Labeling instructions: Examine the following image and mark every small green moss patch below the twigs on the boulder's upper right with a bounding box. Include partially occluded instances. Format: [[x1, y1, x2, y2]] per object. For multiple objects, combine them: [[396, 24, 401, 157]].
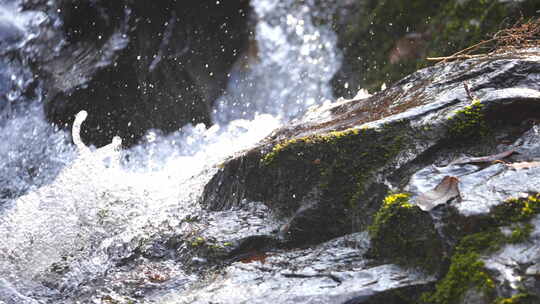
[[449, 100, 489, 139]]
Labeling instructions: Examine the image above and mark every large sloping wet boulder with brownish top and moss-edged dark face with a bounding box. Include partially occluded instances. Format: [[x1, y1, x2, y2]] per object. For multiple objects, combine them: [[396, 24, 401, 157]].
[[202, 48, 540, 243]]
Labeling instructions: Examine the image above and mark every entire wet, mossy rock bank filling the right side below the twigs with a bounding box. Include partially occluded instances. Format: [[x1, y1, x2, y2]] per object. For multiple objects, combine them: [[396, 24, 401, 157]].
[[195, 49, 540, 303]]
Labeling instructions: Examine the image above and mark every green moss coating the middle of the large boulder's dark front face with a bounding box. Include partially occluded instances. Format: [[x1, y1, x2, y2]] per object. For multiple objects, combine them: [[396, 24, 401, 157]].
[[261, 122, 411, 237]]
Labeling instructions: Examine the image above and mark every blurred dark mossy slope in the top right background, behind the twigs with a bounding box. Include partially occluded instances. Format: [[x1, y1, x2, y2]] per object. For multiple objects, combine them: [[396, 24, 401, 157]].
[[333, 0, 540, 98]]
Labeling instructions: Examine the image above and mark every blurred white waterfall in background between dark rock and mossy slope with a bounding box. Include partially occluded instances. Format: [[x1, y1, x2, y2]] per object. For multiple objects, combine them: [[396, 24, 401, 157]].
[[214, 0, 341, 124]]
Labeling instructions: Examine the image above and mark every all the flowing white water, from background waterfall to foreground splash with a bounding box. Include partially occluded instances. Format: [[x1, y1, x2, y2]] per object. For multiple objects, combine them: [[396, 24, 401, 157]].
[[0, 0, 340, 304]]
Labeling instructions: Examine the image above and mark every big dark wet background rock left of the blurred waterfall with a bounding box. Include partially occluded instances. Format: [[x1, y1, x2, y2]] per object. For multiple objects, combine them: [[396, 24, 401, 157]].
[[25, 0, 250, 146]]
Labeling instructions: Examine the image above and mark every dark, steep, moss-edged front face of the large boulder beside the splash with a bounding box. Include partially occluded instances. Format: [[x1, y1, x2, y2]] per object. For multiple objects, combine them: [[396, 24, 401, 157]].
[[202, 120, 418, 245]]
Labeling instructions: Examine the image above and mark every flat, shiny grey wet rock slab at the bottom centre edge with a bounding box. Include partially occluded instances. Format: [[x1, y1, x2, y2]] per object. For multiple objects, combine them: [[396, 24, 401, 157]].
[[177, 233, 434, 303]]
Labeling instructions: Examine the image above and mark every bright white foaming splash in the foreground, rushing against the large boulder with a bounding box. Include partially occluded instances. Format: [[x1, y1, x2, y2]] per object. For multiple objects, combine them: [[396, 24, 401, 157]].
[[0, 108, 278, 298]]
